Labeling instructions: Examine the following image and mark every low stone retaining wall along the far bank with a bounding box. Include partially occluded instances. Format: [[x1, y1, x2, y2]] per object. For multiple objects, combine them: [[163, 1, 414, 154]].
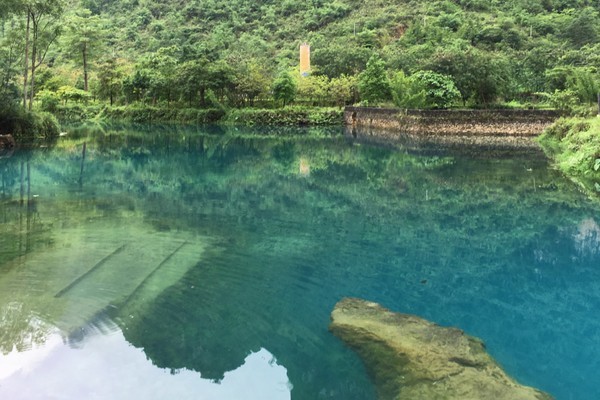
[[344, 107, 560, 142]]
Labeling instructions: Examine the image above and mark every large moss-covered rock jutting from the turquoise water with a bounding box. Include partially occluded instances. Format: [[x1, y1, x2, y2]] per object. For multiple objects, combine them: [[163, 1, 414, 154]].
[[329, 298, 552, 400]]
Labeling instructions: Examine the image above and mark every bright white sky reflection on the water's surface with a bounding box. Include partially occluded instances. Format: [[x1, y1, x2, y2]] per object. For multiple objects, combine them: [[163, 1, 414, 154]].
[[0, 331, 291, 400]]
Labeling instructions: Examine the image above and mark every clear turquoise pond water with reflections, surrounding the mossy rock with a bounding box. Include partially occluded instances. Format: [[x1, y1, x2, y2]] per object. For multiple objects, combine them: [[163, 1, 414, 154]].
[[0, 123, 600, 399]]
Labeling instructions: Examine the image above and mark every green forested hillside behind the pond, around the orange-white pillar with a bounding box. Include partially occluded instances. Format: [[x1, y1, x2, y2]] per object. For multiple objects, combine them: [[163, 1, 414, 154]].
[[0, 0, 600, 119]]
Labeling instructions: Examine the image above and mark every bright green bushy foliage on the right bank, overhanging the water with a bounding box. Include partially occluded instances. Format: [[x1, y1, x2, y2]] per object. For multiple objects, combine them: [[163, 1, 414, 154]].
[[540, 118, 600, 193]]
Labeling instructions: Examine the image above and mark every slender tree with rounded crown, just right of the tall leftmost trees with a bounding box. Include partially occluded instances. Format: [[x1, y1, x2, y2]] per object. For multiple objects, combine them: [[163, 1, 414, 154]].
[[65, 9, 106, 92]]
